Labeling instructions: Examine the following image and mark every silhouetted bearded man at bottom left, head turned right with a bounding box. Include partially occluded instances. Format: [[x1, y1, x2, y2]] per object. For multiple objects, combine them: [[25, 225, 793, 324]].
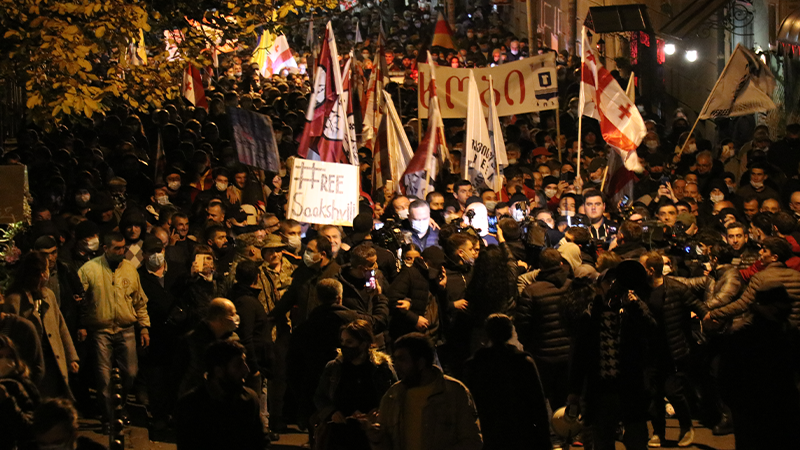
[[175, 341, 265, 450]]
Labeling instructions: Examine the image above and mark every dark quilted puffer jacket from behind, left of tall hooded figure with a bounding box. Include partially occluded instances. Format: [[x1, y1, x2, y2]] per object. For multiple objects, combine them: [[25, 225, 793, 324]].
[[514, 266, 572, 363]]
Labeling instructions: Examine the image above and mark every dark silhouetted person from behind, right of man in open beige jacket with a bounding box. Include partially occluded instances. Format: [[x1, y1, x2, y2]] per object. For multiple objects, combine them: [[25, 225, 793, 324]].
[[464, 314, 551, 450]]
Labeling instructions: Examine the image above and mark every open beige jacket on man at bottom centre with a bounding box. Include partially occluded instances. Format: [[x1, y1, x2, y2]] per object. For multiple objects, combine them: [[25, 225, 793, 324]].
[[372, 369, 483, 450]]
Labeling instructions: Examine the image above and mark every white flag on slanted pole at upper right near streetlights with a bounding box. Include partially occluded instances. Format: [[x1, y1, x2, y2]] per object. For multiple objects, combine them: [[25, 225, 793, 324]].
[[700, 44, 775, 120]]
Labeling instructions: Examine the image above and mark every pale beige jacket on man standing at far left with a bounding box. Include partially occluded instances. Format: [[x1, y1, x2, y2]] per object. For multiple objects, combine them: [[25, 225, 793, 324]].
[[78, 255, 150, 333]]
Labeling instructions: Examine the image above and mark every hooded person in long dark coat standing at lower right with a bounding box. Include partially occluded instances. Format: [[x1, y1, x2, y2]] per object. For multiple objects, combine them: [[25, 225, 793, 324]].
[[567, 261, 656, 450]]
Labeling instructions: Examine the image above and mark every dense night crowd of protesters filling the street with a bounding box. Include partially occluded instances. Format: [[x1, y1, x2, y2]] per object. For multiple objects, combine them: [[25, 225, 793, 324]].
[[0, 2, 800, 450]]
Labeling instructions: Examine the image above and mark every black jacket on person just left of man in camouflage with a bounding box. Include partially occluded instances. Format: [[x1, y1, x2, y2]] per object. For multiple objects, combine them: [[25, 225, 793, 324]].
[[228, 283, 273, 378]]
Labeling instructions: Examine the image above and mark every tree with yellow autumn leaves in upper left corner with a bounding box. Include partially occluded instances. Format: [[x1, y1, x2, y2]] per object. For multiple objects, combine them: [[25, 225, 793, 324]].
[[0, 0, 338, 128]]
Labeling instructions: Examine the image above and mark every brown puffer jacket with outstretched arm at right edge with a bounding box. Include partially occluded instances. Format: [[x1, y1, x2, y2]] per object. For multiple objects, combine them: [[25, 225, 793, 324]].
[[711, 262, 800, 331]]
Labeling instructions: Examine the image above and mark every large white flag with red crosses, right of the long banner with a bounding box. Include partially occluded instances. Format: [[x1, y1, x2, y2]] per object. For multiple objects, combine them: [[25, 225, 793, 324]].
[[579, 28, 647, 172]]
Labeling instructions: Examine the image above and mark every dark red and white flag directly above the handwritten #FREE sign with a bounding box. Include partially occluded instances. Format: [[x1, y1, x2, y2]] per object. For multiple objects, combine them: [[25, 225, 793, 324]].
[[297, 22, 358, 165]]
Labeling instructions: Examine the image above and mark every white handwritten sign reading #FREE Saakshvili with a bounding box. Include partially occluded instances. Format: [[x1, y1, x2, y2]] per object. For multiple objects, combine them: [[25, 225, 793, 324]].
[[288, 158, 359, 226]]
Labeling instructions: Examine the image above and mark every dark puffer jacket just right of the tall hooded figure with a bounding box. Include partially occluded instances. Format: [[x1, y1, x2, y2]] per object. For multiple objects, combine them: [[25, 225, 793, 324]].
[[651, 277, 708, 361]]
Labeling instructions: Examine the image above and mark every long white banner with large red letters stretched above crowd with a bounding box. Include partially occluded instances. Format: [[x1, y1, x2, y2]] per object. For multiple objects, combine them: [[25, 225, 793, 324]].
[[418, 53, 558, 119]]
